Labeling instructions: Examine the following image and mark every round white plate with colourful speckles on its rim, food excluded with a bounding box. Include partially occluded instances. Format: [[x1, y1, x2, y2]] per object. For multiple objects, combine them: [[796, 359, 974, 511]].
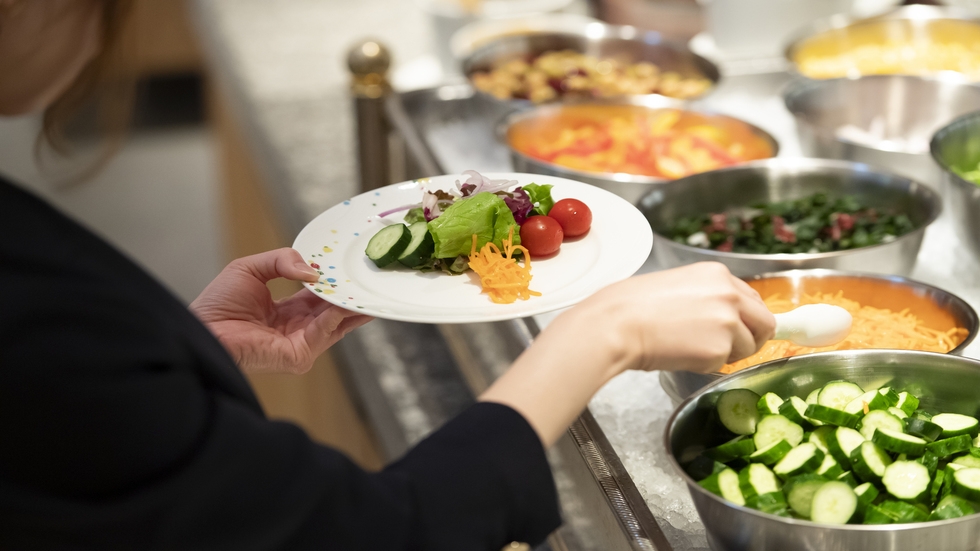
[[293, 173, 653, 323]]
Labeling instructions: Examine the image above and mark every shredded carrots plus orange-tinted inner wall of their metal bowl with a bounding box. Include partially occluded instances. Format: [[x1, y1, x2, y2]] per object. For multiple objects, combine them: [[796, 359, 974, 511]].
[[721, 276, 969, 373]]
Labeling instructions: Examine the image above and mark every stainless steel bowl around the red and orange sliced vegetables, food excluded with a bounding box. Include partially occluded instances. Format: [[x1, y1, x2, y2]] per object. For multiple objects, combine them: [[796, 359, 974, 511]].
[[497, 96, 779, 203]]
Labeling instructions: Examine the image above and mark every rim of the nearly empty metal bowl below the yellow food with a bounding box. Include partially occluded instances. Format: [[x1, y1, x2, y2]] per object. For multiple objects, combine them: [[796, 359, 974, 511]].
[[782, 73, 980, 156]]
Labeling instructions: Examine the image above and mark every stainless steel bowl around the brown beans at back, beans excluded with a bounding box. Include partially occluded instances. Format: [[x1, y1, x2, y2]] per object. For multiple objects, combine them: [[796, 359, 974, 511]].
[[462, 22, 721, 108]]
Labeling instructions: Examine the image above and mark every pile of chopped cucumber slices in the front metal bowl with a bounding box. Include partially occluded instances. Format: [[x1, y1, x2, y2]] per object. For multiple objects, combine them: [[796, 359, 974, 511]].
[[687, 381, 980, 524]]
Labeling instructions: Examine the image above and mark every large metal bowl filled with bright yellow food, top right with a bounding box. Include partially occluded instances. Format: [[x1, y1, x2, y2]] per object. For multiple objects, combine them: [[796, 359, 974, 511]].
[[786, 5, 980, 80]]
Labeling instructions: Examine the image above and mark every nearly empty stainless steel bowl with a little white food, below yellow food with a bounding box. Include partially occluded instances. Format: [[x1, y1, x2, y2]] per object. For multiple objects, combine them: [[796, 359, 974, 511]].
[[783, 75, 980, 190]]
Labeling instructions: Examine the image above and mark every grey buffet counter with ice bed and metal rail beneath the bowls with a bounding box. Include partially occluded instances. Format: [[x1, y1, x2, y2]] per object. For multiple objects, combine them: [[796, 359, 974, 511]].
[[194, 0, 980, 551]]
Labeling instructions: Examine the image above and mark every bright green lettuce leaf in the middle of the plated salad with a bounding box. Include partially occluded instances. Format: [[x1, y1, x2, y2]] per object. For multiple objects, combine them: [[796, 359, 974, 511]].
[[429, 192, 521, 258]]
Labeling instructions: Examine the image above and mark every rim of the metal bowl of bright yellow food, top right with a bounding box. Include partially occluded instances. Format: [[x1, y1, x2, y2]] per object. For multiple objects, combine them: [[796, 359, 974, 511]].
[[783, 4, 980, 80]]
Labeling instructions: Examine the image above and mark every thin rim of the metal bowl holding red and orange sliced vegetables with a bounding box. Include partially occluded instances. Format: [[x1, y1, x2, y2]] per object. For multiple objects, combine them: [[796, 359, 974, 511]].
[[496, 102, 779, 189]]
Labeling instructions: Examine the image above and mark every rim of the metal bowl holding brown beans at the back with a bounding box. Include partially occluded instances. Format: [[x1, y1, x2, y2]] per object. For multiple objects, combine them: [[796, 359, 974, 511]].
[[460, 21, 723, 108]]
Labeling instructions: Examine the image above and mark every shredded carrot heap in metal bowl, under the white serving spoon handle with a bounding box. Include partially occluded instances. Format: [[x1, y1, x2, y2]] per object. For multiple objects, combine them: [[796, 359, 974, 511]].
[[721, 292, 969, 373]]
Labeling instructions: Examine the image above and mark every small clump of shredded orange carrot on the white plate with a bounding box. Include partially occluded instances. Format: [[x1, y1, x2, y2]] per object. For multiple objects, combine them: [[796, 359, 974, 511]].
[[470, 226, 541, 304]]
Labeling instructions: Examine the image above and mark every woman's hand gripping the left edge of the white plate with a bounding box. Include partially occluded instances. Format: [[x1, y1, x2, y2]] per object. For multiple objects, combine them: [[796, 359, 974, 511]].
[[190, 248, 372, 373]]
